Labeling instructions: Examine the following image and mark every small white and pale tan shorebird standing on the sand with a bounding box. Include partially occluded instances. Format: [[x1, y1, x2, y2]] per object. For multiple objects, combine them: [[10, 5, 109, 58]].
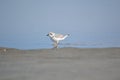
[[47, 32, 69, 48]]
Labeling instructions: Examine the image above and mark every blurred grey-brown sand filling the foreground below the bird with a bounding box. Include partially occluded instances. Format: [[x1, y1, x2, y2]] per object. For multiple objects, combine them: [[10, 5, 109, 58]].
[[0, 48, 120, 80]]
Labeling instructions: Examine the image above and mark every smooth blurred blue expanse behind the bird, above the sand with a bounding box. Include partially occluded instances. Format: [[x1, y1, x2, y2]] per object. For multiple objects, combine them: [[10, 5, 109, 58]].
[[0, 0, 120, 49]]
